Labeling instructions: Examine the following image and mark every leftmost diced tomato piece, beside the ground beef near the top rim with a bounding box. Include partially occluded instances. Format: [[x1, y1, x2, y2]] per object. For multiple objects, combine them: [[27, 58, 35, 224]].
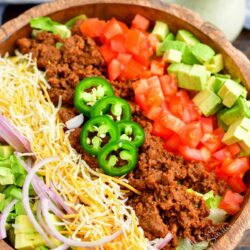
[[80, 18, 106, 38]]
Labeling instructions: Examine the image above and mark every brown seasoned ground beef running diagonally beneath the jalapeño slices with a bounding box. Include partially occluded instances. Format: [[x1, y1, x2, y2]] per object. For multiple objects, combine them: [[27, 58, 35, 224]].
[[17, 23, 227, 249]]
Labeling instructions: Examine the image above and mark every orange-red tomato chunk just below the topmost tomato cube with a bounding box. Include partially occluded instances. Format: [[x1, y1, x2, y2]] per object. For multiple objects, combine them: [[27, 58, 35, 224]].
[[125, 29, 146, 55]]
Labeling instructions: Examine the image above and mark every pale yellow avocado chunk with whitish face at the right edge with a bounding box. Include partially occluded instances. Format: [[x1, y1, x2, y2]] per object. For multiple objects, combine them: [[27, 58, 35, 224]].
[[222, 117, 250, 145]]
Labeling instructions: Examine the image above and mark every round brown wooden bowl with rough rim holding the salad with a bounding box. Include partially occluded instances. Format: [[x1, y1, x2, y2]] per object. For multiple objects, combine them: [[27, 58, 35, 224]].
[[0, 0, 250, 250]]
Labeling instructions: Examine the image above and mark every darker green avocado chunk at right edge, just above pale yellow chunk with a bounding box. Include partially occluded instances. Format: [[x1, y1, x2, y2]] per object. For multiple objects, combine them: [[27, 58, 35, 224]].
[[220, 97, 250, 125]]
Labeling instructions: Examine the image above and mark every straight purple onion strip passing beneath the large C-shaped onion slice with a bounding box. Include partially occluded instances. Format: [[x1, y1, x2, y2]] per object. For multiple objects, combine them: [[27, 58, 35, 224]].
[[15, 153, 75, 217]]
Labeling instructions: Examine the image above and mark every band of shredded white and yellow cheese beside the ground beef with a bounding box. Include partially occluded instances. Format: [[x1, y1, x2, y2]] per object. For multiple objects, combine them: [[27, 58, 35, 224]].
[[0, 54, 152, 250]]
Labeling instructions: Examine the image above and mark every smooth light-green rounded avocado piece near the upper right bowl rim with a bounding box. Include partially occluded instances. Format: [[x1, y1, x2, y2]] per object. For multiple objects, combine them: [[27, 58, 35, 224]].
[[191, 43, 215, 63]]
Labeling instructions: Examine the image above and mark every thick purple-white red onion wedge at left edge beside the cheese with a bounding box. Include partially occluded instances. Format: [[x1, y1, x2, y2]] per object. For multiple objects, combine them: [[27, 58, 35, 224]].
[[0, 114, 31, 153]]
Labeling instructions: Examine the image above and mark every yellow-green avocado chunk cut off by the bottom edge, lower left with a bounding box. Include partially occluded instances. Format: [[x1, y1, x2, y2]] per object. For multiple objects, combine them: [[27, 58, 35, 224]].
[[15, 233, 46, 250]]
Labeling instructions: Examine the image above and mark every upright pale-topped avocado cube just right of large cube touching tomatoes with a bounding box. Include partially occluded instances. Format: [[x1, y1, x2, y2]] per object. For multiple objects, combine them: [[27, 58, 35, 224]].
[[187, 64, 208, 90]]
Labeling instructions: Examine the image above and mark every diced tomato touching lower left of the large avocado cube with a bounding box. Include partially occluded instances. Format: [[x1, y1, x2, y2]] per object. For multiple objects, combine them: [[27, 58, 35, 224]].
[[159, 75, 178, 97]]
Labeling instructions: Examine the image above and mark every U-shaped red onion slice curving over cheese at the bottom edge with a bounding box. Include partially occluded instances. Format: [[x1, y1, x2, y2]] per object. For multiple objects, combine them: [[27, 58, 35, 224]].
[[41, 198, 122, 248]]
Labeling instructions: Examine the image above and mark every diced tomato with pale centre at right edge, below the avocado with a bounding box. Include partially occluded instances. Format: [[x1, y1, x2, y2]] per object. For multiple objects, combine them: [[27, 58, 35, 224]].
[[222, 157, 250, 177]]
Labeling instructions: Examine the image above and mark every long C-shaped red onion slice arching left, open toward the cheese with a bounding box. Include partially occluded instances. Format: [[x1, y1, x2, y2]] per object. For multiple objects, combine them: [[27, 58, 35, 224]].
[[22, 157, 59, 248]]
